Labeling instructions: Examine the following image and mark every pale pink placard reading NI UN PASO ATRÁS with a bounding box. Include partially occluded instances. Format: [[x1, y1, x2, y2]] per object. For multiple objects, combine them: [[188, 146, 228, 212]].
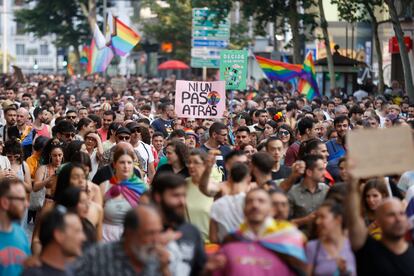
[[175, 80, 226, 118]]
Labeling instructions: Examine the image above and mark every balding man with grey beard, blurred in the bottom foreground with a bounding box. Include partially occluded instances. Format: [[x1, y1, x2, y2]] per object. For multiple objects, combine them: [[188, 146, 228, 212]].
[[71, 204, 171, 276]]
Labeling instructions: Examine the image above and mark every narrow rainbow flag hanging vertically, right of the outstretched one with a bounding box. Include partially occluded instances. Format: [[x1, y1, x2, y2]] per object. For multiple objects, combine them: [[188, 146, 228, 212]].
[[298, 52, 320, 101]]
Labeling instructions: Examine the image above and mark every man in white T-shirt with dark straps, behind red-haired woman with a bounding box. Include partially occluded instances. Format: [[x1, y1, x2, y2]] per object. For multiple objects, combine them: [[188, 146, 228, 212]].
[[126, 121, 155, 180]]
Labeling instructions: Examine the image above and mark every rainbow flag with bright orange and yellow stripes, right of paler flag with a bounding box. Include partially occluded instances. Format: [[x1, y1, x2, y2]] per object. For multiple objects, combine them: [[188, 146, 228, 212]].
[[110, 17, 141, 56]]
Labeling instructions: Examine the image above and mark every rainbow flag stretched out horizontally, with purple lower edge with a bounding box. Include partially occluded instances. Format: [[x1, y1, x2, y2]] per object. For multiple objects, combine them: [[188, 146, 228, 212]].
[[256, 56, 303, 82]]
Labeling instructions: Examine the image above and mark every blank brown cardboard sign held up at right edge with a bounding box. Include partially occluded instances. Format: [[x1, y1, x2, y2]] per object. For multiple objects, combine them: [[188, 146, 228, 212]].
[[347, 127, 414, 178]]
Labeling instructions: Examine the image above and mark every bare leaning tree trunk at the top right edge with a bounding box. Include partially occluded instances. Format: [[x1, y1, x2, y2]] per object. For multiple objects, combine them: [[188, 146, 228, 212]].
[[385, 0, 414, 102]]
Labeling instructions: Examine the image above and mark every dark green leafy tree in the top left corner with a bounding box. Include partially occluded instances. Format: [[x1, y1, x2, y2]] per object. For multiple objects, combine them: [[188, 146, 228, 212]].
[[15, 0, 101, 71]]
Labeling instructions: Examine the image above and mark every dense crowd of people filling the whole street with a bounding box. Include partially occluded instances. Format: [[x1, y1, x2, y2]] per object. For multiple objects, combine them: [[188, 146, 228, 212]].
[[0, 75, 414, 276]]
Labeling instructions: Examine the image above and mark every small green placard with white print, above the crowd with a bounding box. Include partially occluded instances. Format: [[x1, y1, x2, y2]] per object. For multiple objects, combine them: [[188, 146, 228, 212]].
[[220, 50, 248, 90]]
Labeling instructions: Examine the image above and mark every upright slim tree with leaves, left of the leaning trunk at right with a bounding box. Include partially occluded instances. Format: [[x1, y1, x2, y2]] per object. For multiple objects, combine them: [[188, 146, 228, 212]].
[[331, 0, 386, 93]]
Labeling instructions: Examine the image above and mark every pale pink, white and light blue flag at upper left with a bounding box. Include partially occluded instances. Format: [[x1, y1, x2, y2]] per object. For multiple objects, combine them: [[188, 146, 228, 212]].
[[86, 24, 114, 74]]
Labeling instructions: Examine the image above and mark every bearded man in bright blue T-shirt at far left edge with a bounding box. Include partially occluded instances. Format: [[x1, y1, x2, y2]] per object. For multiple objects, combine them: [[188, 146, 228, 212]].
[[0, 177, 30, 275]]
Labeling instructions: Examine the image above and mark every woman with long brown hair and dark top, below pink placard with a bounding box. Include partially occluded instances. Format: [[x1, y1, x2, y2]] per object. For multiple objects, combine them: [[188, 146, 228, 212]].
[[154, 140, 190, 178]]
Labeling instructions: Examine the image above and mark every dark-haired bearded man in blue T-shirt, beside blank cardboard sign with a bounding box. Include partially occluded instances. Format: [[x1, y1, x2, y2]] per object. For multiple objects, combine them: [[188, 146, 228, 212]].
[[326, 115, 350, 181]]
